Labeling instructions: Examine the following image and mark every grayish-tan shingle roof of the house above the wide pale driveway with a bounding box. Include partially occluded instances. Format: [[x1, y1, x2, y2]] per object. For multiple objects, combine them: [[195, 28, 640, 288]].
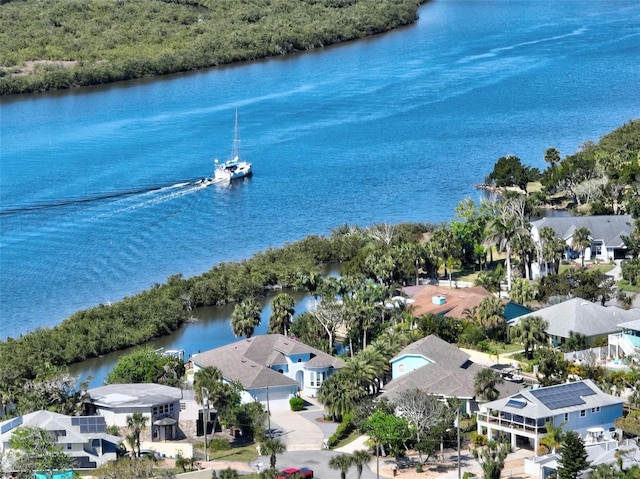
[[192, 334, 344, 389]]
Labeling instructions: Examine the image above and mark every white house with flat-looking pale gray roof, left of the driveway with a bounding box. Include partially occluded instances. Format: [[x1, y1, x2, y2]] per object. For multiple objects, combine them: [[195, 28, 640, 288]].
[[85, 383, 184, 441]]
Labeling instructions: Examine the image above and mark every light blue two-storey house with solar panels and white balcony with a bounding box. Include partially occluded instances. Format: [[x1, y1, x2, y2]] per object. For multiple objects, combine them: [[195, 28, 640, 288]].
[[477, 379, 624, 454]]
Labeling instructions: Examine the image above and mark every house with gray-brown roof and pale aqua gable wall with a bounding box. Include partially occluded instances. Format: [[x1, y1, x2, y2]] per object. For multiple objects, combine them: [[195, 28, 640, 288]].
[[382, 334, 521, 413]]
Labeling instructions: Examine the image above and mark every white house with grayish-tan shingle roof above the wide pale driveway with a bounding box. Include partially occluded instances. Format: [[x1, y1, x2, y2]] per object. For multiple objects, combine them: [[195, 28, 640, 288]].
[[191, 334, 344, 408]]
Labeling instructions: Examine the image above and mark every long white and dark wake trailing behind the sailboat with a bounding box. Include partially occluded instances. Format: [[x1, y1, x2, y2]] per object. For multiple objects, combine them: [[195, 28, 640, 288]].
[[0, 178, 208, 216]]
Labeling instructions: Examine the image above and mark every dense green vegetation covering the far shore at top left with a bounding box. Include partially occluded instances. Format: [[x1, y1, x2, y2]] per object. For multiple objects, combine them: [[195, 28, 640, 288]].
[[0, 0, 418, 95]]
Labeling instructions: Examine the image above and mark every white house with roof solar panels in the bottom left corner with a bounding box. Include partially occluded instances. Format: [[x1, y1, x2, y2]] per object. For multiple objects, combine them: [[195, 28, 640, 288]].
[[0, 411, 122, 472]]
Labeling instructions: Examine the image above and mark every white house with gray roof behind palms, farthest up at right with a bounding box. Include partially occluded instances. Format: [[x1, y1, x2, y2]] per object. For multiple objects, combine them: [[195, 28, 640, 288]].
[[531, 215, 633, 278]]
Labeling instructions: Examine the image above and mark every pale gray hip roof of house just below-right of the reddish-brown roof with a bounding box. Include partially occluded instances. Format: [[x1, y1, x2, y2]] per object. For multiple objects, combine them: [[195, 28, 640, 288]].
[[508, 298, 640, 346]]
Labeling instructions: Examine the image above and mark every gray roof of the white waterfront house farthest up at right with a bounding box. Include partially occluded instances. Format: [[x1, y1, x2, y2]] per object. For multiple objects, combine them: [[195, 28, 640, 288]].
[[531, 215, 633, 247]]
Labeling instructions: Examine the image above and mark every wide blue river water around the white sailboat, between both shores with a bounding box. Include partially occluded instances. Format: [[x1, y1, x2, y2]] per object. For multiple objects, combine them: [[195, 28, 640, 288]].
[[0, 0, 640, 338]]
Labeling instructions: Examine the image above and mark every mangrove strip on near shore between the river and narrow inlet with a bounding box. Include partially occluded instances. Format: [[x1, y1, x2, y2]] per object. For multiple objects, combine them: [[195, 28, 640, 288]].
[[0, 225, 426, 389]]
